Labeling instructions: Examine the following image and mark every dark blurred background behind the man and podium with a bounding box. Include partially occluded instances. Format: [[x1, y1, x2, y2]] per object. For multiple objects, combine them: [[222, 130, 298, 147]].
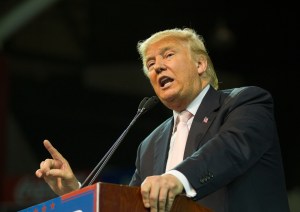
[[0, 0, 300, 212]]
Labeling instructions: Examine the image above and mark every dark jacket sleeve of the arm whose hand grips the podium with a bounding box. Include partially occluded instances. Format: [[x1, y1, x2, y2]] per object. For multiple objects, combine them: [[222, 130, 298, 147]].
[[176, 87, 278, 198]]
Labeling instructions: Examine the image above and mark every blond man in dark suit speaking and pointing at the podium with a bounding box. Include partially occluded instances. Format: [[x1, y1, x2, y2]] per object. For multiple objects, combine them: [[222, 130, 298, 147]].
[[36, 28, 289, 212]]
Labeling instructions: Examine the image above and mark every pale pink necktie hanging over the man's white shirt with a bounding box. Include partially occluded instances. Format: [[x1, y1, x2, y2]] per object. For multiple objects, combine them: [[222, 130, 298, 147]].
[[166, 110, 192, 171]]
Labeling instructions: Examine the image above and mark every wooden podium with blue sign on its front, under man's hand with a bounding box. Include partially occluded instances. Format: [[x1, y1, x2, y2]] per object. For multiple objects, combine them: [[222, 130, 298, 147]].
[[19, 182, 212, 212]]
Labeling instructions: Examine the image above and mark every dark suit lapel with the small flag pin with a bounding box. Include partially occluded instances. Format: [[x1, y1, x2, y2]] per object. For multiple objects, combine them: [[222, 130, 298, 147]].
[[184, 88, 220, 158]]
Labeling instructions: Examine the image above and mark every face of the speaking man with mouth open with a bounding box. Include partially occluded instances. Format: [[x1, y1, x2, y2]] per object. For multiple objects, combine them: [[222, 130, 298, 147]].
[[145, 37, 204, 111]]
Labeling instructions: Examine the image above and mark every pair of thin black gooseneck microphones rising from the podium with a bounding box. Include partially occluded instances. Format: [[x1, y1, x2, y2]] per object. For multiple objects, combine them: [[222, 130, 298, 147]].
[[80, 96, 158, 188]]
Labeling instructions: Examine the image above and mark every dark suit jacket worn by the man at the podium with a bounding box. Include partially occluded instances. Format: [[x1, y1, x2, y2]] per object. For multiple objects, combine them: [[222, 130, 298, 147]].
[[130, 86, 289, 212]]
